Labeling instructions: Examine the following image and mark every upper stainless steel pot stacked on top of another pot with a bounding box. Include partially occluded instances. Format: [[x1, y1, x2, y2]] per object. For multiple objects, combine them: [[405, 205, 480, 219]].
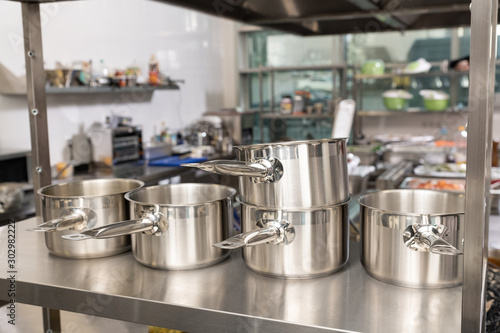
[[183, 138, 349, 208]]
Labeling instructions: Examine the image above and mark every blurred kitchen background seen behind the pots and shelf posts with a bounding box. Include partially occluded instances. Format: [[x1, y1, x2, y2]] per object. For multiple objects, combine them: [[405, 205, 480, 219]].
[[0, 0, 500, 222]]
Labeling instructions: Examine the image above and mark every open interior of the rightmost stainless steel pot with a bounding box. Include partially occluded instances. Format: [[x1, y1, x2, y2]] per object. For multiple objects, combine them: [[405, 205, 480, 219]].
[[358, 189, 465, 215]]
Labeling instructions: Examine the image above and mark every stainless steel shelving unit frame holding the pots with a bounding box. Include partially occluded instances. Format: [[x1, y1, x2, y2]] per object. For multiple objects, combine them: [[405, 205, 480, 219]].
[[0, 0, 498, 332]]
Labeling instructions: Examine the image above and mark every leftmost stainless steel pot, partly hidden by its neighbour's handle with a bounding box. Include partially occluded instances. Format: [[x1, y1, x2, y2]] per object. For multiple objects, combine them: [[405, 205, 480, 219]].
[[30, 179, 144, 259]]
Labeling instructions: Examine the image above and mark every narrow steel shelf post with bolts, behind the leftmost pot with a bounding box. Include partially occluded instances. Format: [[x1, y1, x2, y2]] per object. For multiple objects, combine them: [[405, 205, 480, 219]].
[[22, 2, 52, 215]]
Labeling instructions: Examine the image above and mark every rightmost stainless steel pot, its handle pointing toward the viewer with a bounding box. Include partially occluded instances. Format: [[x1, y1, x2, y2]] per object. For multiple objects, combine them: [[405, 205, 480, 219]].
[[358, 189, 465, 288]]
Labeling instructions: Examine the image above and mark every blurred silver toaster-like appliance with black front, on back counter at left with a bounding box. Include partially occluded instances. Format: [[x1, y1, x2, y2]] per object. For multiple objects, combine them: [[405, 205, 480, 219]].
[[88, 118, 143, 167]]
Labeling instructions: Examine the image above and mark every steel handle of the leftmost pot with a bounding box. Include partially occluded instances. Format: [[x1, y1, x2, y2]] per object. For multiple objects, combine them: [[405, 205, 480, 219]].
[[26, 208, 97, 232]]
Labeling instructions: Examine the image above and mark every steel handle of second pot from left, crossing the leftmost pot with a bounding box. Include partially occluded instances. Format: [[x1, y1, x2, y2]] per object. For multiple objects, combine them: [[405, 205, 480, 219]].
[[61, 213, 168, 241]]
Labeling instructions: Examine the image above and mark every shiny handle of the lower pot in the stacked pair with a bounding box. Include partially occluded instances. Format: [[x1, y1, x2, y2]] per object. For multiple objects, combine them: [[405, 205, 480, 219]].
[[212, 219, 295, 250]]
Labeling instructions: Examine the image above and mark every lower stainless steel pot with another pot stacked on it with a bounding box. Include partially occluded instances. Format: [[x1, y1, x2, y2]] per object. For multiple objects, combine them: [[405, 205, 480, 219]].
[[214, 202, 349, 279]]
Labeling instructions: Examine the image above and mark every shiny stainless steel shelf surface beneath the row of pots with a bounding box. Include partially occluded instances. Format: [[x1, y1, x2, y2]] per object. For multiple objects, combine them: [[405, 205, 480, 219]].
[[0, 217, 462, 333]]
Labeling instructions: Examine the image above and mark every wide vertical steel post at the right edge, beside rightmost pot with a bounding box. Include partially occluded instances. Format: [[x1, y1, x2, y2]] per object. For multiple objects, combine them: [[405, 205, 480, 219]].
[[462, 0, 498, 333]]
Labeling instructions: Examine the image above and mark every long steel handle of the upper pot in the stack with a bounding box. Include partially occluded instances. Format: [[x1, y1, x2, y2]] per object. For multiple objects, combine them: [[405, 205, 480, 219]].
[[181, 157, 283, 183]]
